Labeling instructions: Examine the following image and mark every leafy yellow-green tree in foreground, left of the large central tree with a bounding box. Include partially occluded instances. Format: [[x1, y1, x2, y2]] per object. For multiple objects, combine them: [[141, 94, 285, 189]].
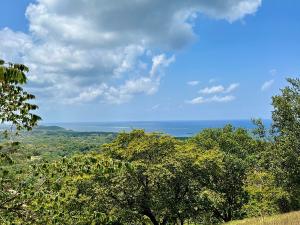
[[27, 153, 119, 225]]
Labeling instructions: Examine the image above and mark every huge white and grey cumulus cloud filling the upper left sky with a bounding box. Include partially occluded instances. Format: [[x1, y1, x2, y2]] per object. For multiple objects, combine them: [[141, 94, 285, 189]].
[[0, 0, 261, 103]]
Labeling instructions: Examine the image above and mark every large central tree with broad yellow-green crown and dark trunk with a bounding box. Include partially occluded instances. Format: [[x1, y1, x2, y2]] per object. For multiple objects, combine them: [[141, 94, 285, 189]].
[[100, 130, 199, 225]]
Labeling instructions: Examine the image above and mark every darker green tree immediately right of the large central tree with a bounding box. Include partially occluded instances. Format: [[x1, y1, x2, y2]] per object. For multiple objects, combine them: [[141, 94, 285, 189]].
[[190, 125, 258, 222]]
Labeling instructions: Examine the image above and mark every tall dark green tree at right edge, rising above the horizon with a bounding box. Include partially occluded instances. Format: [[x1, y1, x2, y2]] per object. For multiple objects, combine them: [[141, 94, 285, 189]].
[[272, 78, 300, 211]]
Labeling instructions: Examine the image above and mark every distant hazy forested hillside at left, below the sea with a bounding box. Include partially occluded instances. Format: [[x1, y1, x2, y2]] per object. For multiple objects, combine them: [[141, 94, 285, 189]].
[[0, 126, 116, 163]]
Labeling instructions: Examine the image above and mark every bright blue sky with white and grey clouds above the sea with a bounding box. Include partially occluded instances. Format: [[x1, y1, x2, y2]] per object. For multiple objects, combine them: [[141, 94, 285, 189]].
[[0, 0, 300, 122]]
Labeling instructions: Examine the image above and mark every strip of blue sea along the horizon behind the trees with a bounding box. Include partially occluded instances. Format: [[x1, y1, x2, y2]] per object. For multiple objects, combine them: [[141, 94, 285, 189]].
[[43, 120, 271, 137]]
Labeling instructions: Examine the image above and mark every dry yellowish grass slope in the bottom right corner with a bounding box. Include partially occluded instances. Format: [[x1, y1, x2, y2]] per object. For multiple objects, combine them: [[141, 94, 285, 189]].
[[224, 211, 300, 225]]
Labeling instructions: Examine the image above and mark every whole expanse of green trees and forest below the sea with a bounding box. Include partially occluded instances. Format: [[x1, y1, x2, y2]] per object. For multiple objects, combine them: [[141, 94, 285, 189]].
[[0, 60, 300, 225]]
